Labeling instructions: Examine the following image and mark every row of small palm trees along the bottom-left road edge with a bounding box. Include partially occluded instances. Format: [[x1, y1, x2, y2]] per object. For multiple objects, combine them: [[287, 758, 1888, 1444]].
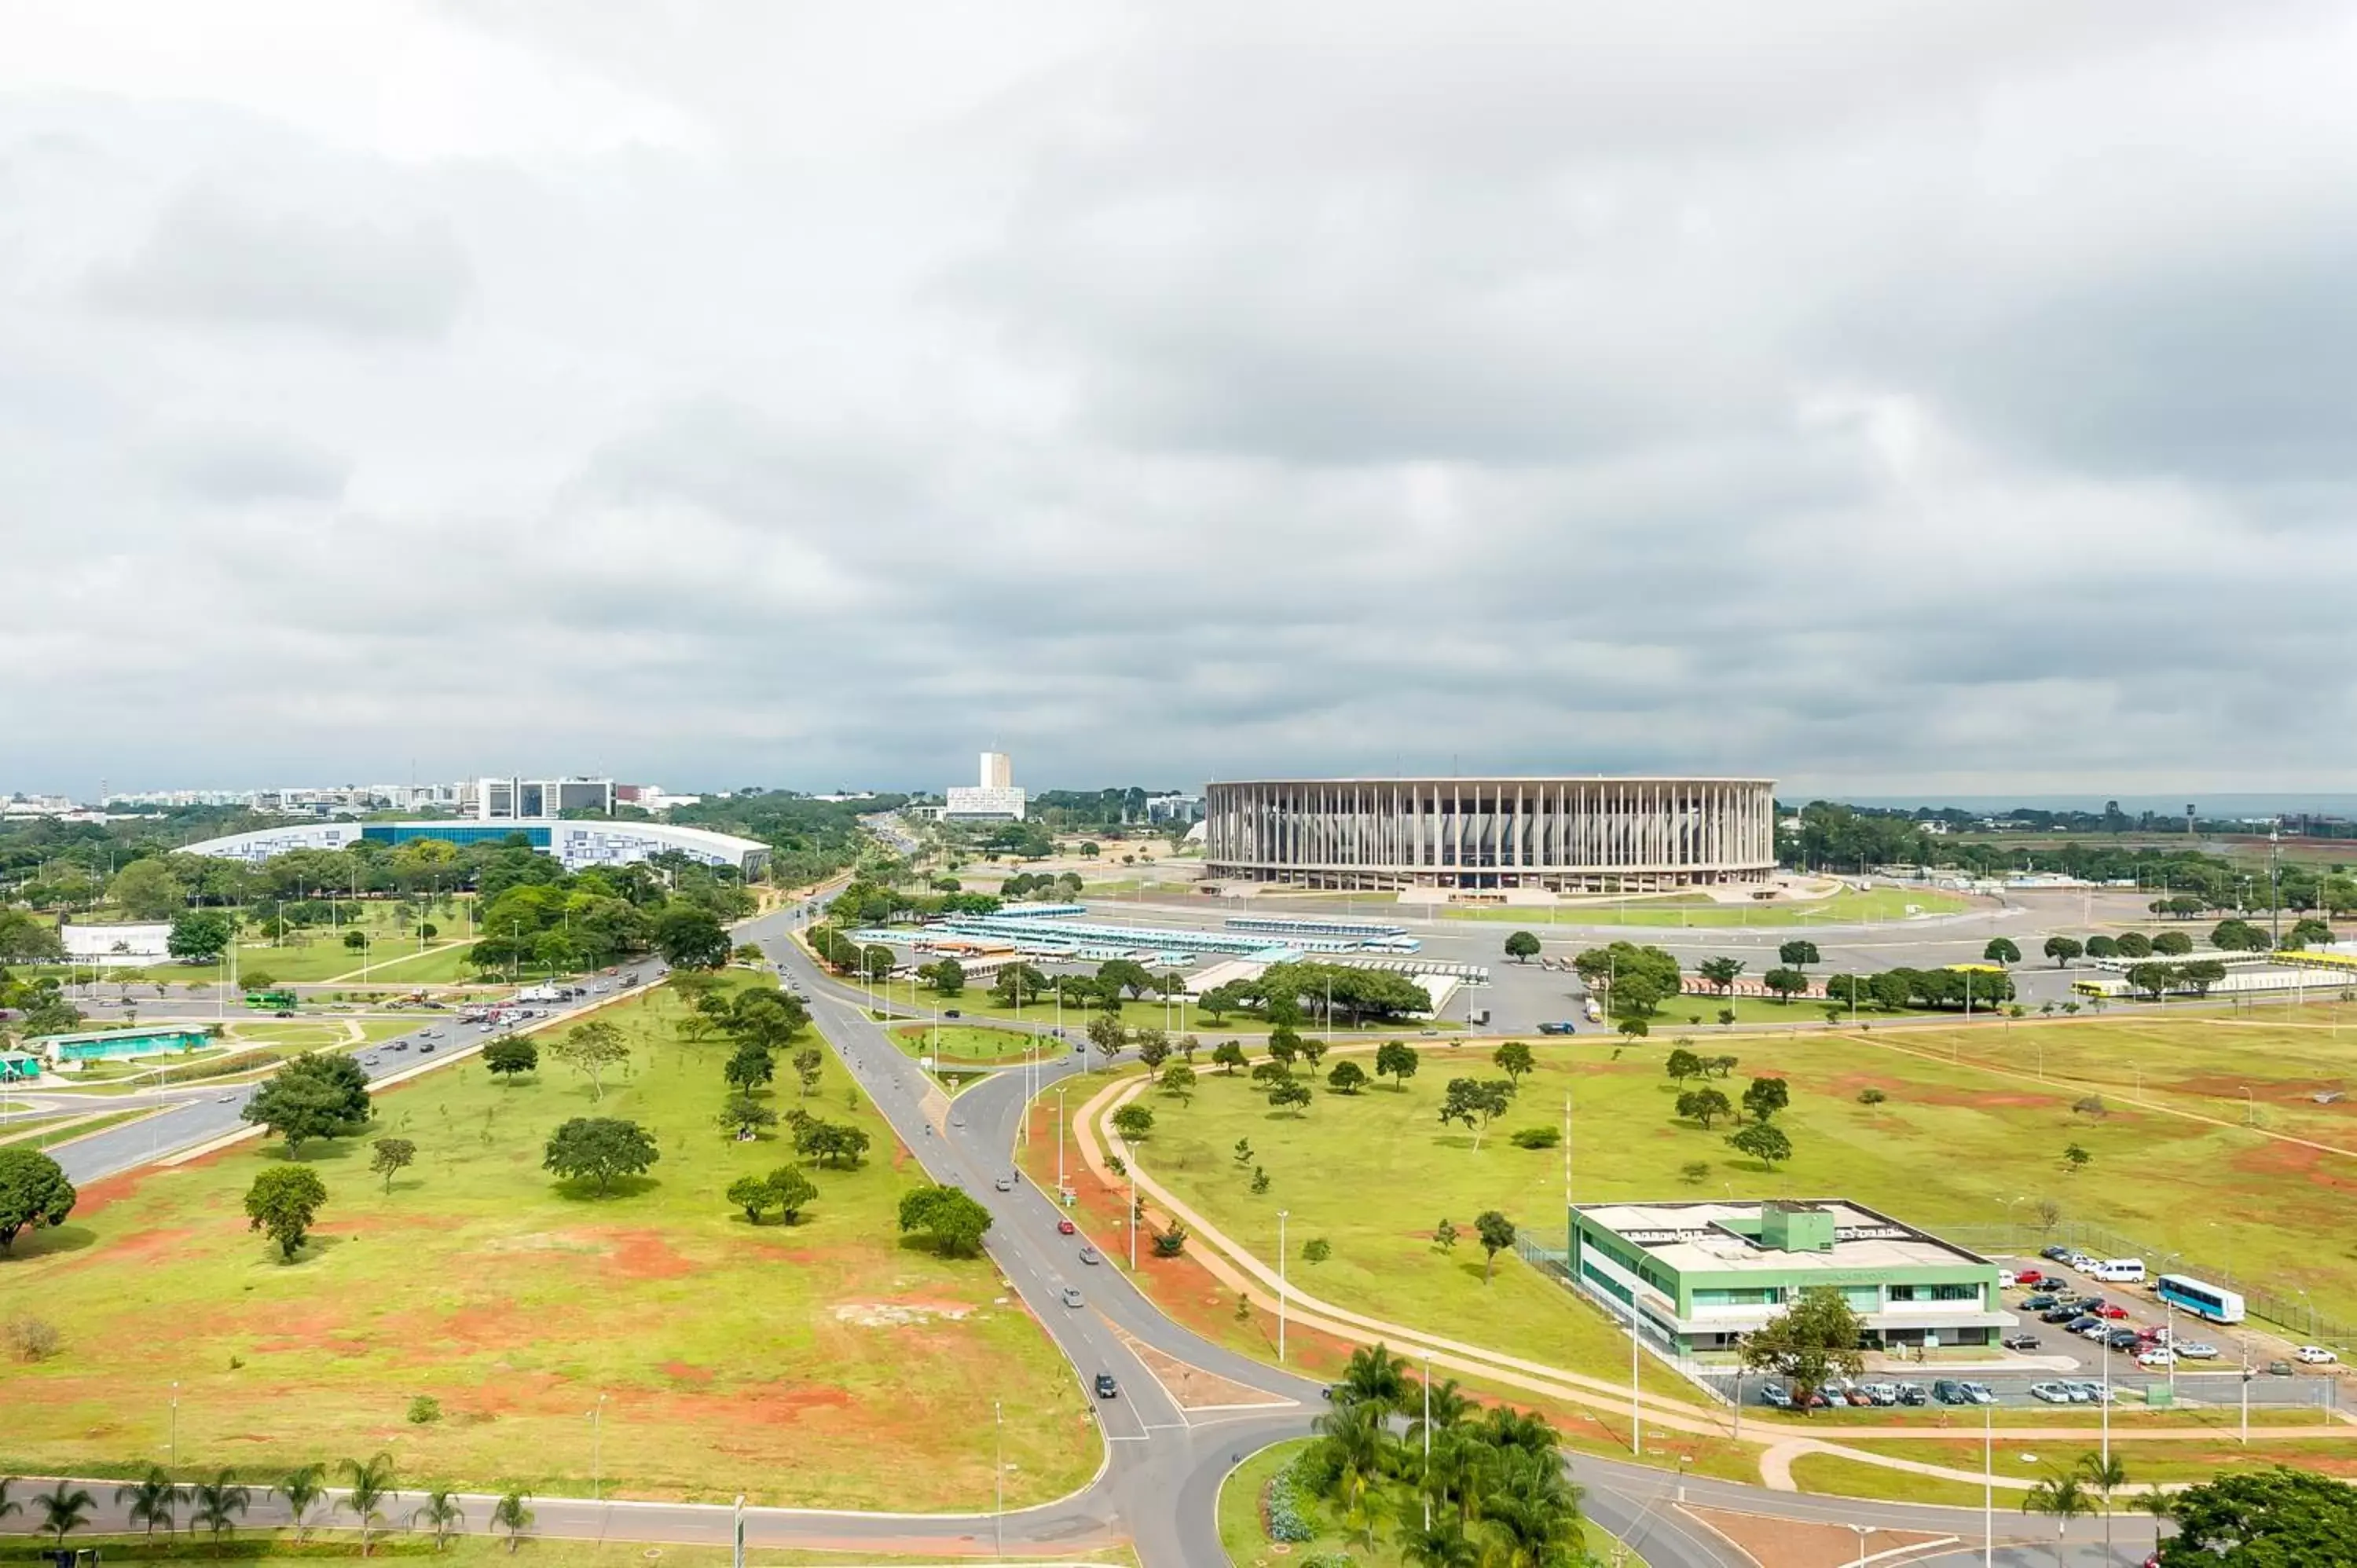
[[0, 1453, 533, 1556]]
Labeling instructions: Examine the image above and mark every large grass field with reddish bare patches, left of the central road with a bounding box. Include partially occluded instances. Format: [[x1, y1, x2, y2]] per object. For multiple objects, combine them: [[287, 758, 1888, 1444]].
[[0, 991, 1098, 1509]]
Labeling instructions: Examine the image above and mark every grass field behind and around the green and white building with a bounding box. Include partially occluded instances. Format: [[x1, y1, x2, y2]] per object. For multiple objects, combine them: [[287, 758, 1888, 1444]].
[[1141, 1019, 2357, 1370]]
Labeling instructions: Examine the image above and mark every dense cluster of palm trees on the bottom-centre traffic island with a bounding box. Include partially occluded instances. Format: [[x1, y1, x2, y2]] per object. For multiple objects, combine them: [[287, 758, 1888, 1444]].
[[1308, 1344, 1589, 1568]]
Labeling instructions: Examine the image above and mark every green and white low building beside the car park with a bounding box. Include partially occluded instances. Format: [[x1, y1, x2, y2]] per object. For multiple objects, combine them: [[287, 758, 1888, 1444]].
[[1570, 1198, 2018, 1361]]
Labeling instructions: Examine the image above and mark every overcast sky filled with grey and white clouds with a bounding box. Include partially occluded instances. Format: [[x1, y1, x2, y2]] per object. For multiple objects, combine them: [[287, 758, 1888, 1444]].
[[0, 0, 2357, 795]]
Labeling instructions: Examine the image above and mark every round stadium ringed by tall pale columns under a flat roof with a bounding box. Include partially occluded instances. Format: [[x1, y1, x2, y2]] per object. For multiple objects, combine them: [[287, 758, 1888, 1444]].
[[1204, 778, 1775, 894]]
